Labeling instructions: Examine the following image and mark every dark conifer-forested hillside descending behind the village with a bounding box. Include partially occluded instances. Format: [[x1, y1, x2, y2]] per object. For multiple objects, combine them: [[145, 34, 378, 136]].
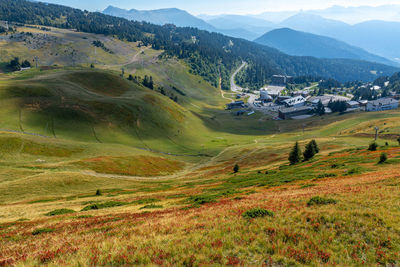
[[0, 0, 397, 89]]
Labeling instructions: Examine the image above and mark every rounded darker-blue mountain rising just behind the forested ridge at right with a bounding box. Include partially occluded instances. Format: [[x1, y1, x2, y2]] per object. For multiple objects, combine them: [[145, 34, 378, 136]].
[[255, 28, 398, 66]]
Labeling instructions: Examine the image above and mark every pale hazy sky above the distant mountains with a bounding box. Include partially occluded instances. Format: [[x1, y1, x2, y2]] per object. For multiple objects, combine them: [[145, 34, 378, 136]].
[[43, 0, 400, 15]]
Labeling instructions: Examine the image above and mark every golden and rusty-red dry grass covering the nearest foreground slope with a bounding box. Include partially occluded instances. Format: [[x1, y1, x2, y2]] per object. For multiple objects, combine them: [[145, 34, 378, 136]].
[[0, 144, 400, 266]]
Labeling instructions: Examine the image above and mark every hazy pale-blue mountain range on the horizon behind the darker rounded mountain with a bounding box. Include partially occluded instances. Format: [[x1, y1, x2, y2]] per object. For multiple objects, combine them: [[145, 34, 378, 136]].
[[103, 6, 400, 64]]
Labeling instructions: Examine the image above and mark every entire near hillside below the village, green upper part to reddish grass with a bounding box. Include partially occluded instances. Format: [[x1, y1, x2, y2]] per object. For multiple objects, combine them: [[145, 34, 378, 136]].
[[0, 107, 400, 266]]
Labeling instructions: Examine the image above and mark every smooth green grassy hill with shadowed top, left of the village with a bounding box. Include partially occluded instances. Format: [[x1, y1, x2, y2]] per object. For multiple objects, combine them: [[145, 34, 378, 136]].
[[0, 27, 288, 155]]
